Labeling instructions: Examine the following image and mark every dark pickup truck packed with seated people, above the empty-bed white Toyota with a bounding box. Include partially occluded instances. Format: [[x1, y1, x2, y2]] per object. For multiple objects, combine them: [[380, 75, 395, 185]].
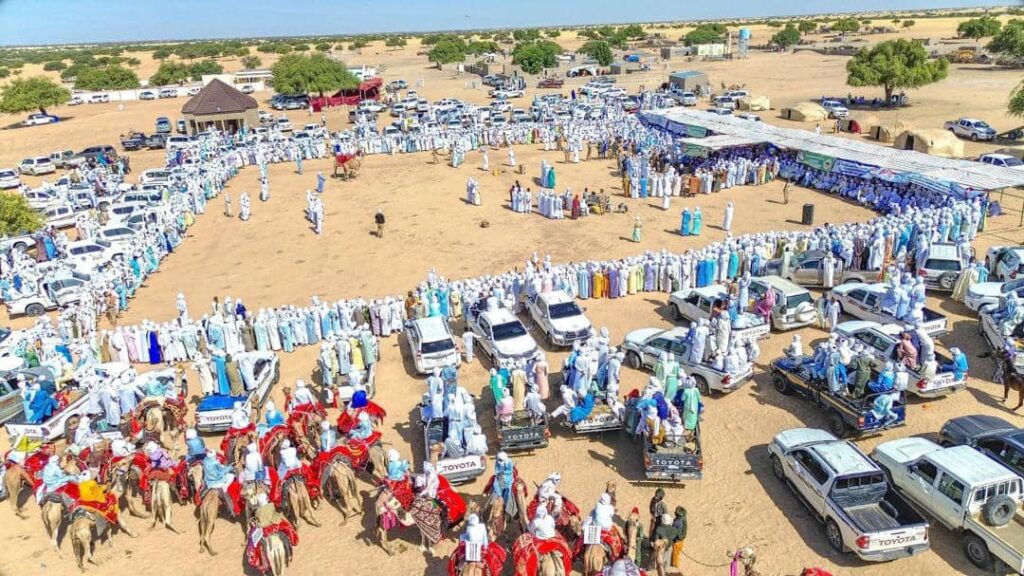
[[771, 357, 906, 438]]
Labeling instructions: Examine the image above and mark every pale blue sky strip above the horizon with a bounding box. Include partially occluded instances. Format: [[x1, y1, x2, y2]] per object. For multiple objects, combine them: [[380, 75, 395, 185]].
[[0, 0, 997, 45]]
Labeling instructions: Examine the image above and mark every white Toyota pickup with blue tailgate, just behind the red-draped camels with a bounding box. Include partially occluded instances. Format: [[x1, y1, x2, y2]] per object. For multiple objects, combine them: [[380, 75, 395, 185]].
[[196, 352, 281, 434]]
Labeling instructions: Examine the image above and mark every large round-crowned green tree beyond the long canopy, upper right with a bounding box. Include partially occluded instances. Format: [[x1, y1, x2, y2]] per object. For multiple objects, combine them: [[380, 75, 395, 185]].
[[846, 40, 949, 101]]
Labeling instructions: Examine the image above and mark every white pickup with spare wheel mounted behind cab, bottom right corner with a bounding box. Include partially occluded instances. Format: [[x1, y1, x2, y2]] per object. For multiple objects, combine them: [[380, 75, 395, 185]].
[[871, 438, 1024, 574]]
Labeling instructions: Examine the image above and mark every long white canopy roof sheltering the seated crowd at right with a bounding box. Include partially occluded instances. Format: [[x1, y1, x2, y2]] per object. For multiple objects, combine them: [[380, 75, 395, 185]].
[[640, 107, 1024, 191]]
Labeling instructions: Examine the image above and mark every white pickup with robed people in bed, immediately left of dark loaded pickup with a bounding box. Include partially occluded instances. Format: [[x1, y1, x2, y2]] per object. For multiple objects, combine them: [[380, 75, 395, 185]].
[[622, 328, 754, 396]]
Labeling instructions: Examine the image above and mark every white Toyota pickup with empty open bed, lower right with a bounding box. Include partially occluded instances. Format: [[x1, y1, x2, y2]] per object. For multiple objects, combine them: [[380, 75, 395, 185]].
[[768, 428, 930, 562]]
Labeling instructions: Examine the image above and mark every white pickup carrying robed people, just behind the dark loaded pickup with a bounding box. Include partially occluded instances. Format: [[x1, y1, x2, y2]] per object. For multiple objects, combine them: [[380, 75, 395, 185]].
[[836, 320, 967, 398]]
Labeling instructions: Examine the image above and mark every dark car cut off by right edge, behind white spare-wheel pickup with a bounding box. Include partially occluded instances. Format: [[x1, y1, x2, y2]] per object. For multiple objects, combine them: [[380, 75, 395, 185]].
[[939, 414, 1024, 478]]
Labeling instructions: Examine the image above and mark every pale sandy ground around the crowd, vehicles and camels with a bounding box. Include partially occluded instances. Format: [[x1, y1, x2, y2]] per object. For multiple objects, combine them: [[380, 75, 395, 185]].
[[0, 15, 1021, 576]]
